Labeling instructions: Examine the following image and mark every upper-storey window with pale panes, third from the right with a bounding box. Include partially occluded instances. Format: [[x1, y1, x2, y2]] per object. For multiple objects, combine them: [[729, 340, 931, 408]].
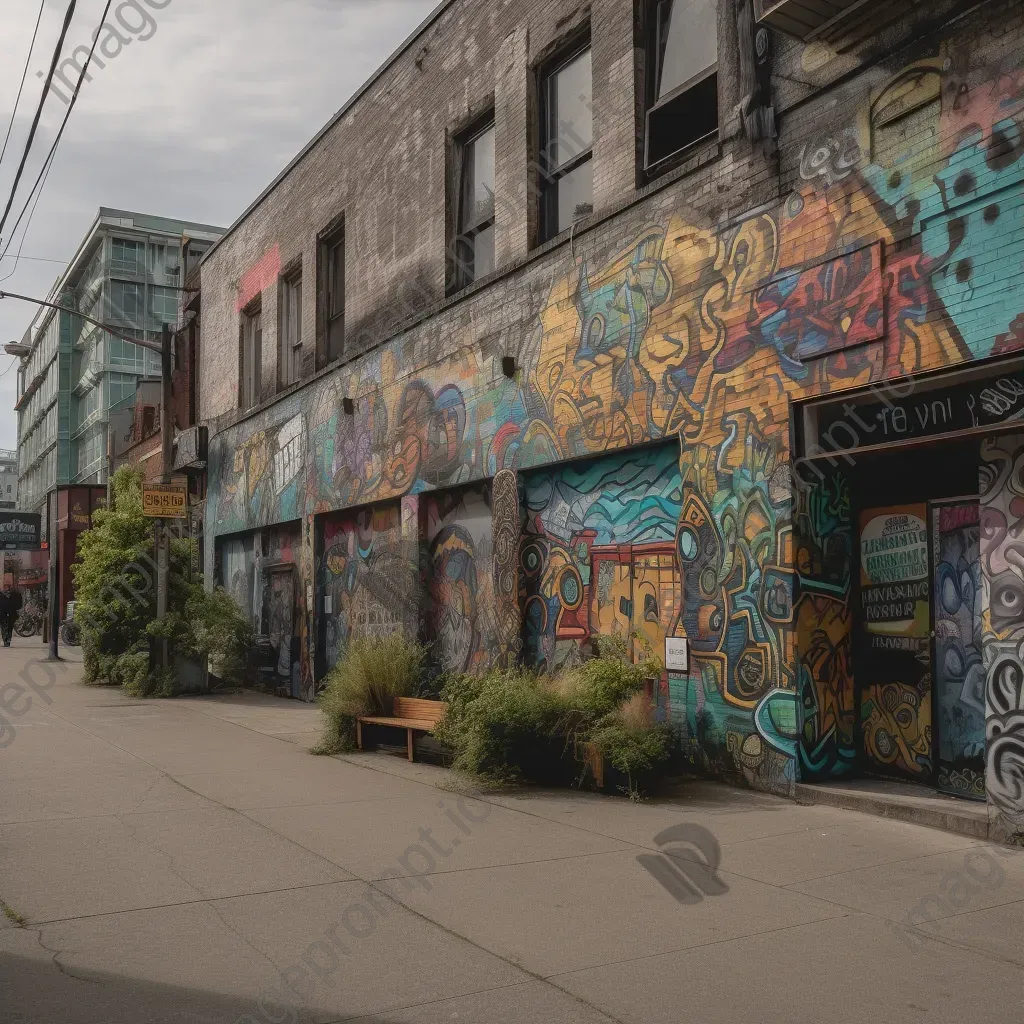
[[452, 115, 495, 289]]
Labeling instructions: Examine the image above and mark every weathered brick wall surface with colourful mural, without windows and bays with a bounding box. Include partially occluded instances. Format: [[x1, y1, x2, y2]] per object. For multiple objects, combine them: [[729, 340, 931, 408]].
[[197, 0, 1024, 791]]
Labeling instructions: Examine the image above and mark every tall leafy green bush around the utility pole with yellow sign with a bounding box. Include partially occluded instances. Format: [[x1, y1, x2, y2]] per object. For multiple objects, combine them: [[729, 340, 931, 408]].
[[72, 467, 252, 696]]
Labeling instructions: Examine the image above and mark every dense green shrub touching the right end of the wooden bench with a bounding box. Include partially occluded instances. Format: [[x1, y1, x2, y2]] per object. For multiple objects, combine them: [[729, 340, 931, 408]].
[[434, 669, 565, 782]]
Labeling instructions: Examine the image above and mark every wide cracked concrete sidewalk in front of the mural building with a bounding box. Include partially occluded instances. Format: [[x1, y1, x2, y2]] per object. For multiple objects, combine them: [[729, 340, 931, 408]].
[[0, 641, 1024, 1024]]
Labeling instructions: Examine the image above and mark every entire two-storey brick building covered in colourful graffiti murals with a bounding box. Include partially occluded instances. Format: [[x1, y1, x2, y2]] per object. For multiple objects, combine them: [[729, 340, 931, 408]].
[[199, 0, 1024, 836]]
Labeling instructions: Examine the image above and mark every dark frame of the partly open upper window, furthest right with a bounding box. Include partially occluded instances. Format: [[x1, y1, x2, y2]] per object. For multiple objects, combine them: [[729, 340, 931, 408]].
[[640, 0, 721, 180]]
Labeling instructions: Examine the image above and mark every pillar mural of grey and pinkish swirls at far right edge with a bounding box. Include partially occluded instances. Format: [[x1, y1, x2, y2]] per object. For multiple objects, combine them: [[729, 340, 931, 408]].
[[981, 434, 1024, 844]]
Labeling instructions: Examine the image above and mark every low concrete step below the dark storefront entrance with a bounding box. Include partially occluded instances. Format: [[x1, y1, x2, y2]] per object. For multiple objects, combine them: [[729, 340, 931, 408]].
[[796, 778, 988, 839]]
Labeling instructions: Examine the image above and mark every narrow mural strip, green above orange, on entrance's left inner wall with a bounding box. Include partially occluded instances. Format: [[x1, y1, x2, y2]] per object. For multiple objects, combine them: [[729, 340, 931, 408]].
[[794, 466, 857, 779]]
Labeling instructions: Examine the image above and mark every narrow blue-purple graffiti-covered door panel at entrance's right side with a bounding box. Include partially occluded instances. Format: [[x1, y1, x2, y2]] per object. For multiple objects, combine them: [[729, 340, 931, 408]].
[[932, 501, 985, 800]]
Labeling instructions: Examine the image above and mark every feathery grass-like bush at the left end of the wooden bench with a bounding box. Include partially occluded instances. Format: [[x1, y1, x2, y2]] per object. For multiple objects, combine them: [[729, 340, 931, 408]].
[[312, 633, 426, 754]]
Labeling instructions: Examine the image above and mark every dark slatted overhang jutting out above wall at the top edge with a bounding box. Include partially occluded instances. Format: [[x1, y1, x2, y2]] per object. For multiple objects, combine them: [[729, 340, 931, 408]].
[[754, 0, 922, 49]]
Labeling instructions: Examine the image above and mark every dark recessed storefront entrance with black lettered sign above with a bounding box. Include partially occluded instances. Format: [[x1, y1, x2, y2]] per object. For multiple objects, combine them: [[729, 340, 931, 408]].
[[795, 360, 1024, 800]]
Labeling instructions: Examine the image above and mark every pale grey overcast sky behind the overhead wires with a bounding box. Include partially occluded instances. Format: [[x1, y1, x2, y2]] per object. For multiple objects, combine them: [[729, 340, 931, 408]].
[[0, 0, 437, 449]]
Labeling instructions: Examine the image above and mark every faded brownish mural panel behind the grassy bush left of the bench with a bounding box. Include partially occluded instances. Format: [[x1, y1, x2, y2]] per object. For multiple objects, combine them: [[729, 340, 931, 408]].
[[316, 502, 419, 671]]
